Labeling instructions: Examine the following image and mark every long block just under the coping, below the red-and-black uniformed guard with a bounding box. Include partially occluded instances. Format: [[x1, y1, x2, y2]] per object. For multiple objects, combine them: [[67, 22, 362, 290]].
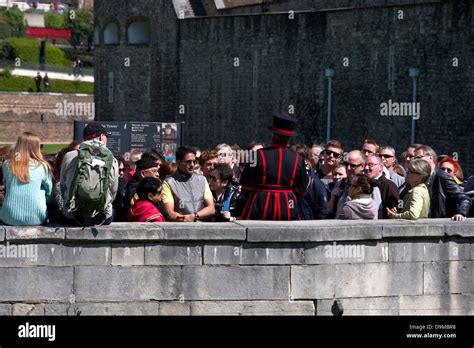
[[204, 243, 304, 265]]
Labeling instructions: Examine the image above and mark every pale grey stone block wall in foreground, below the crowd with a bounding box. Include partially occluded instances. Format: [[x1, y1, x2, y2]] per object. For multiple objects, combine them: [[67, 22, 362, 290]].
[[0, 219, 474, 315]]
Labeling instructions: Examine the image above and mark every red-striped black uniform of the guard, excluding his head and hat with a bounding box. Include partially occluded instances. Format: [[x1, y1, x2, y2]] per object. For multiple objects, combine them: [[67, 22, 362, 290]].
[[240, 146, 309, 221]]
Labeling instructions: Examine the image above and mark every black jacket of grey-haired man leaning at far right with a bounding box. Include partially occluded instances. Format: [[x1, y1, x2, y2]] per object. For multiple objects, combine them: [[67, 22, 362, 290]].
[[429, 168, 471, 218]]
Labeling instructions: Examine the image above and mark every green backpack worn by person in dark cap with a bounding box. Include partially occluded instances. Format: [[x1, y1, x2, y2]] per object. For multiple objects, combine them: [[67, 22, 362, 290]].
[[68, 144, 114, 226]]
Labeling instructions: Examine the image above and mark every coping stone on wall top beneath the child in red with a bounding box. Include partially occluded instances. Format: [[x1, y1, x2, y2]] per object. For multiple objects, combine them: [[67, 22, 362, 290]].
[[66, 222, 164, 241]]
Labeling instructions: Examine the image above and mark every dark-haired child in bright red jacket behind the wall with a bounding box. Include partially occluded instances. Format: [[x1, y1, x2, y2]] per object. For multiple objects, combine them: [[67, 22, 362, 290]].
[[127, 177, 165, 222]]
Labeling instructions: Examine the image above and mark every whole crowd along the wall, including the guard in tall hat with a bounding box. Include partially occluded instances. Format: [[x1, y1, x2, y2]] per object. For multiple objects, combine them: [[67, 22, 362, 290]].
[[0, 114, 474, 226]]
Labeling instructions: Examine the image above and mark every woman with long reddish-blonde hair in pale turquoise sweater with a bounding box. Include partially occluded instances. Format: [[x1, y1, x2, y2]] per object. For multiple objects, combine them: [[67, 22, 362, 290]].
[[0, 132, 53, 226]]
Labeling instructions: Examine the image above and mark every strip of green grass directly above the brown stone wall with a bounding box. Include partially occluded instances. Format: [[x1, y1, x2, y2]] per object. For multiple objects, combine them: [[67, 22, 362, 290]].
[[0, 74, 94, 94]]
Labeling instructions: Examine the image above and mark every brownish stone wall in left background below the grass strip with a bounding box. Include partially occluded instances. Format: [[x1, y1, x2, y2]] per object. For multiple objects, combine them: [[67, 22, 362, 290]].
[[0, 92, 94, 143]]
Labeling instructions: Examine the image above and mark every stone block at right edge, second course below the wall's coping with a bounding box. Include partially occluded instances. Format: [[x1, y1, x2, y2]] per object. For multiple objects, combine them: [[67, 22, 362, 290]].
[[424, 261, 474, 295]]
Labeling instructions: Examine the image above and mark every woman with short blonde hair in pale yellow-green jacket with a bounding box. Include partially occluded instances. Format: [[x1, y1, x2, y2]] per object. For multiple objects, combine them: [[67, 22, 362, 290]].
[[387, 159, 431, 220]]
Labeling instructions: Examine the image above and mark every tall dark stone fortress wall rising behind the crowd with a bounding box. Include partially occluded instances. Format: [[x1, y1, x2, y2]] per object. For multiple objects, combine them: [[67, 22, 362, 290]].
[[95, 0, 474, 174]]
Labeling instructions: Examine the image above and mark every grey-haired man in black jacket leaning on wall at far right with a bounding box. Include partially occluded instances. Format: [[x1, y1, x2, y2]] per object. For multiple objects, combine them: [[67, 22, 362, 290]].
[[414, 145, 472, 221]]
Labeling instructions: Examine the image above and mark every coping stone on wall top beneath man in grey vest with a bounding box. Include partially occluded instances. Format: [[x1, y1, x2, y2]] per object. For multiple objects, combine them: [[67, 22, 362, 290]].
[[163, 222, 246, 241]]
